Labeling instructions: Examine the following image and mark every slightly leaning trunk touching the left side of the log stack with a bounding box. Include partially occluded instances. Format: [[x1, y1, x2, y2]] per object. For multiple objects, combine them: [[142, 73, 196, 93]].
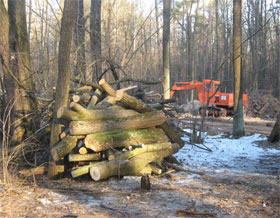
[[48, 0, 75, 178]]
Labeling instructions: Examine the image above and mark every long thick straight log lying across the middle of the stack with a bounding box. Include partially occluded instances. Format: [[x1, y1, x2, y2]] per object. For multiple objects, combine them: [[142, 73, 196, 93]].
[[69, 110, 165, 135]]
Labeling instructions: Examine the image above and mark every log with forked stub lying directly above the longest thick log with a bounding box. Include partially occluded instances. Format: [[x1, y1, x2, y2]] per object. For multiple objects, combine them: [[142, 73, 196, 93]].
[[57, 102, 138, 121]]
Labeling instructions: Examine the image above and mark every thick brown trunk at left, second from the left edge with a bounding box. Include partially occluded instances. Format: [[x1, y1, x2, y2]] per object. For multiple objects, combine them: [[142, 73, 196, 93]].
[[8, 0, 37, 142]]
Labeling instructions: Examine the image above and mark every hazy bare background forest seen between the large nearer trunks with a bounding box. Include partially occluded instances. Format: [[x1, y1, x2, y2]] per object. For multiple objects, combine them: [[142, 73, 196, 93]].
[[19, 0, 280, 98]]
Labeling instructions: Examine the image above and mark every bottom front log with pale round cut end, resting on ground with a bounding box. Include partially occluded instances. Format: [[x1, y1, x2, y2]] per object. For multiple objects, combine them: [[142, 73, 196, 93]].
[[90, 145, 179, 181]]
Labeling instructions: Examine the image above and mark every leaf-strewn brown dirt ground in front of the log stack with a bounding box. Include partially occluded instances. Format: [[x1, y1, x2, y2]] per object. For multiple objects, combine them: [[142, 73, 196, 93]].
[[0, 116, 280, 218]]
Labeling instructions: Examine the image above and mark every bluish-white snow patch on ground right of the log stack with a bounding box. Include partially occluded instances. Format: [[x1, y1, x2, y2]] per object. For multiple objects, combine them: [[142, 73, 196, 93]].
[[175, 130, 280, 174]]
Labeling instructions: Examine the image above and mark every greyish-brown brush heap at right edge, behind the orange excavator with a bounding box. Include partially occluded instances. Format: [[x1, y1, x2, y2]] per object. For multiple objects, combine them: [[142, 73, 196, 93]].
[[247, 89, 280, 118]]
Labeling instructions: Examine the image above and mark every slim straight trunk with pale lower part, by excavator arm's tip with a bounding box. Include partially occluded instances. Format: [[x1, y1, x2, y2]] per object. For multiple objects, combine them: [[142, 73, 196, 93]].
[[162, 0, 171, 99]]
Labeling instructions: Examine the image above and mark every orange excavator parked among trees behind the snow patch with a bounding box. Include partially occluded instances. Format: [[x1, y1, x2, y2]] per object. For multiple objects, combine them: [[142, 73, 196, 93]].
[[170, 80, 248, 116]]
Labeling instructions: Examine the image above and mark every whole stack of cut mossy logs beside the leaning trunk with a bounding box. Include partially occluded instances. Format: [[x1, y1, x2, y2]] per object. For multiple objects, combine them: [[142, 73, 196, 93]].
[[51, 79, 184, 181]]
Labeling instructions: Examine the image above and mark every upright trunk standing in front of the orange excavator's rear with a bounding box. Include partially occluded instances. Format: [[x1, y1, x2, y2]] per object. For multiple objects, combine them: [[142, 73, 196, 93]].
[[232, 0, 245, 138]]
